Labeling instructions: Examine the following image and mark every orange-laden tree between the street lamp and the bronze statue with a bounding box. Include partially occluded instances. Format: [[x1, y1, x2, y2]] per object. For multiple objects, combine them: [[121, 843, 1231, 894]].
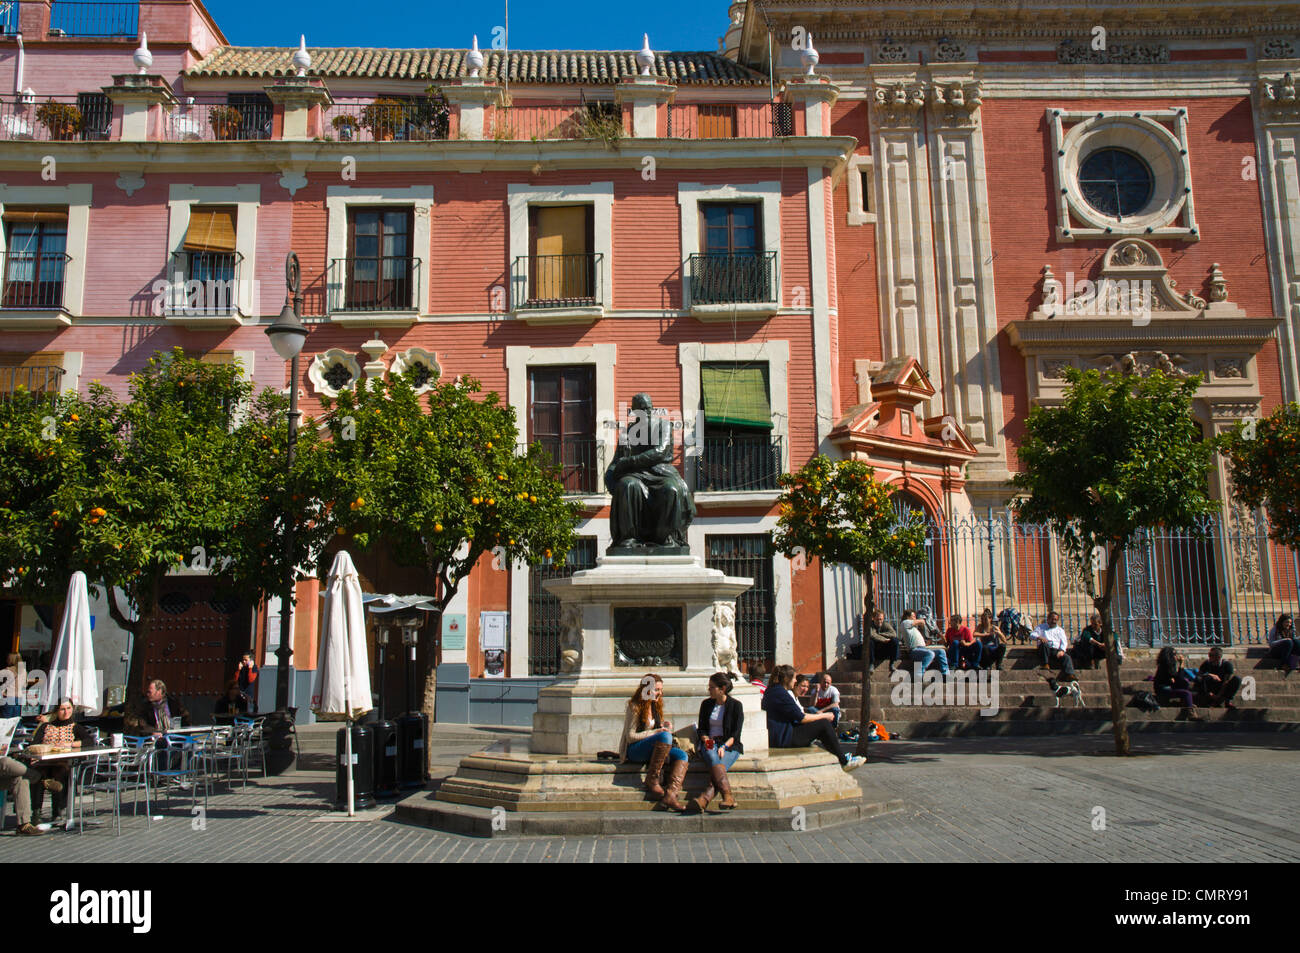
[[322, 369, 579, 712]]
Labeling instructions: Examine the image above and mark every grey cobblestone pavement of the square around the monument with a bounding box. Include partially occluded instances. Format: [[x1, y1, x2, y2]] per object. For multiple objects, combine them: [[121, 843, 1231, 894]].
[[0, 735, 1300, 863]]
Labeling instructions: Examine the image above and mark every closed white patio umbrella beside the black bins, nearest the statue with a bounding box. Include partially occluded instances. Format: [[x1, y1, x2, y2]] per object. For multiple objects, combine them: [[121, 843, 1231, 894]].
[[312, 553, 373, 816]]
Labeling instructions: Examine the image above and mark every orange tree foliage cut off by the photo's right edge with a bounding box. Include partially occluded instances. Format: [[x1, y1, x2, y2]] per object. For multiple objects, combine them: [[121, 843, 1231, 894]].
[[1218, 403, 1300, 549]]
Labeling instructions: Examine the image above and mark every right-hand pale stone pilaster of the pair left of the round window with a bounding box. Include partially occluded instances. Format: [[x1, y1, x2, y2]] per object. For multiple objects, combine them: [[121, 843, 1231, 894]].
[[928, 73, 1010, 484]]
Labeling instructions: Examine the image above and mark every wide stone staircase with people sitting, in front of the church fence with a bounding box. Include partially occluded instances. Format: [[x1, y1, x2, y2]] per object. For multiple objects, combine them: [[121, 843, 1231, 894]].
[[831, 646, 1300, 738]]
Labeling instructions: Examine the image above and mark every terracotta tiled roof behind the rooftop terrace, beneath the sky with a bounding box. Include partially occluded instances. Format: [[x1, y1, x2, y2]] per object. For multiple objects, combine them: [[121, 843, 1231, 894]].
[[185, 47, 767, 86]]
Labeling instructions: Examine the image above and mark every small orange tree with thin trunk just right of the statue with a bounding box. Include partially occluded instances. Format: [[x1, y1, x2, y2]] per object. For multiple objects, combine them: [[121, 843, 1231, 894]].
[[772, 455, 926, 755]]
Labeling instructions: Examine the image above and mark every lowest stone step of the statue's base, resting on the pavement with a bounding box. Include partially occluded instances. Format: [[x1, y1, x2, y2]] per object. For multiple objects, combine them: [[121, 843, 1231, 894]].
[[394, 790, 904, 837]]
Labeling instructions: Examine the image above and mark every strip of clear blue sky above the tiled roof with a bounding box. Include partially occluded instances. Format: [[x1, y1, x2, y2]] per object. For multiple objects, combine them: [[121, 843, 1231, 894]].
[[198, 0, 731, 51]]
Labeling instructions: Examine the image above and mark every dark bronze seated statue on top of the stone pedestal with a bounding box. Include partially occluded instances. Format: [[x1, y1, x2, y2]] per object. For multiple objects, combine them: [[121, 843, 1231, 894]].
[[605, 394, 696, 555]]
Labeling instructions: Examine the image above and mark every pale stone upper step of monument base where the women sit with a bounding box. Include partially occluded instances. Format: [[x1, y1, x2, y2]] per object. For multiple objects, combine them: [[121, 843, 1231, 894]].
[[437, 741, 862, 814]]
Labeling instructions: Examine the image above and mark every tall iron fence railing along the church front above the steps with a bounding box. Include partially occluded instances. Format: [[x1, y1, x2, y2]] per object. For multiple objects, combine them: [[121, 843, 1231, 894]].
[[835, 504, 1300, 655]]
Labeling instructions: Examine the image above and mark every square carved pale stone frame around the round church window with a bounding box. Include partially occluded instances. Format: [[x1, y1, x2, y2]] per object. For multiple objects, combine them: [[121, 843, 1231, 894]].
[[1047, 107, 1200, 242]]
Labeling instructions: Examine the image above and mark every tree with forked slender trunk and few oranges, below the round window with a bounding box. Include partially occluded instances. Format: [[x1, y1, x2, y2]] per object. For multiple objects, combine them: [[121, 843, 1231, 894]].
[[1011, 368, 1214, 755]]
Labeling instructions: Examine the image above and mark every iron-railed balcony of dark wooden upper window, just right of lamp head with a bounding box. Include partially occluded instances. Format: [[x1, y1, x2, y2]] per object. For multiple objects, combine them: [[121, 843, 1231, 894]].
[[326, 255, 423, 328]]
